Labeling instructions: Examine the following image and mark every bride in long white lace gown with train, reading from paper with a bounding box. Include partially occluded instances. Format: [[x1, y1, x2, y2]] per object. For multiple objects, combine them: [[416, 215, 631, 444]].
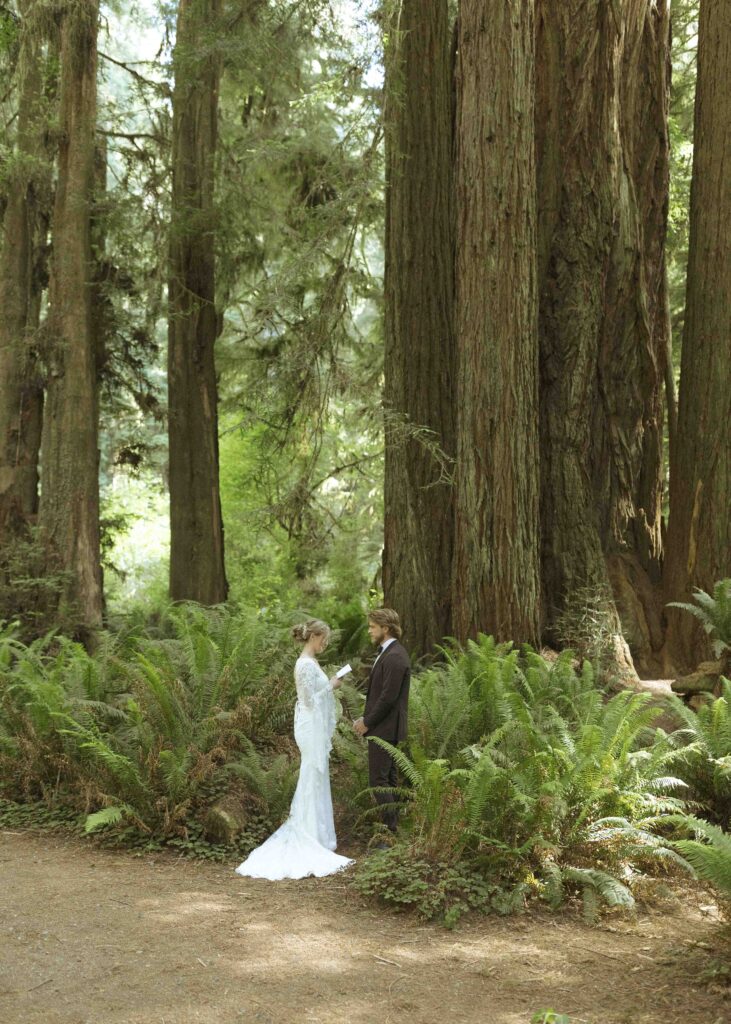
[[237, 618, 353, 881]]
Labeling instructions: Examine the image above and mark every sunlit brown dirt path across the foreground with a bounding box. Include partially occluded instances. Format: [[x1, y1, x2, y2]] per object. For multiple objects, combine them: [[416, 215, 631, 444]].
[[0, 831, 731, 1024]]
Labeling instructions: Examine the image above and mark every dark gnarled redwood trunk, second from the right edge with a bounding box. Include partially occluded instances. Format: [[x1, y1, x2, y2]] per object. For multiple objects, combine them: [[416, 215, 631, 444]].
[[593, 0, 675, 674]]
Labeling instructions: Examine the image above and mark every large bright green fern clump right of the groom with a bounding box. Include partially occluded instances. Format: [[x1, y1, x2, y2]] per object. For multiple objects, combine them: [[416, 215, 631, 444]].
[[356, 636, 688, 918]]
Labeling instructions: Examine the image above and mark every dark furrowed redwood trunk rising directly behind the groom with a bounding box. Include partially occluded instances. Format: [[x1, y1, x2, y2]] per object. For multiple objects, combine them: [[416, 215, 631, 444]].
[[383, 0, 455, 655]]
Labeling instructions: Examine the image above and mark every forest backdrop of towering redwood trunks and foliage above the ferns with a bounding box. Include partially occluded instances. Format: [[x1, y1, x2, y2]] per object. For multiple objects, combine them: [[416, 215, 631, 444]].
[[0, 0, 731, 681]]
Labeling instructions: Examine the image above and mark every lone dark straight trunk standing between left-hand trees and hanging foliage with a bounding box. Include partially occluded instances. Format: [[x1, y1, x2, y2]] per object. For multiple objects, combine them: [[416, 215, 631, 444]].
[[168, 0, 227, 604]]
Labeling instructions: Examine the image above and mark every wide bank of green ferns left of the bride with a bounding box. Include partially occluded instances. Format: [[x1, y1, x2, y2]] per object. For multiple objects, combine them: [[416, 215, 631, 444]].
[[0, 604, 296, 837]]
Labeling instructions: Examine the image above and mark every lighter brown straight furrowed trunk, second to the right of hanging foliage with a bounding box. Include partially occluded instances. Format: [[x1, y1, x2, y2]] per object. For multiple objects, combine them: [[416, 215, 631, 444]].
[[454, 0, 541, 643]]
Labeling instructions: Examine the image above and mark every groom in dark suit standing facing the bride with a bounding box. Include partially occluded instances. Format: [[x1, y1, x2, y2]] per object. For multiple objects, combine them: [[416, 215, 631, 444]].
[[353, 608, 412, 831]]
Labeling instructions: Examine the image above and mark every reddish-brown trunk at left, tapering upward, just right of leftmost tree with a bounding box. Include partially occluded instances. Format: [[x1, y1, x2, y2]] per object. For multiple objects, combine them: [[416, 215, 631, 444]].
[[39, 0, 101, 632]]
